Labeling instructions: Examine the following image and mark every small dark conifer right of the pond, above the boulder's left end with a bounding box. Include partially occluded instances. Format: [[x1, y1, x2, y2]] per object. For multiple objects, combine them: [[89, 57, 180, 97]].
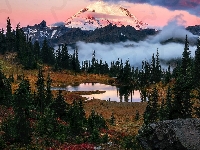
[[143, 87, 158, 125]]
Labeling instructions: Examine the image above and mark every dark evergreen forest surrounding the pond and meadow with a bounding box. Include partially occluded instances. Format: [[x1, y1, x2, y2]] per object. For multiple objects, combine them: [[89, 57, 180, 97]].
[[0, 18, 200, 149]]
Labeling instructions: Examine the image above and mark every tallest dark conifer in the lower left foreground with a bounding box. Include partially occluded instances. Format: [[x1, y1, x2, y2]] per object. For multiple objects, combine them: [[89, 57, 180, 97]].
[[11, 79, 32, 144]]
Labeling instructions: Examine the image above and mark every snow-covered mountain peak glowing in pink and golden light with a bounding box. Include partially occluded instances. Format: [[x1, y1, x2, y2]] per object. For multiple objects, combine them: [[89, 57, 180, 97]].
[[65, 1, 148, 30]]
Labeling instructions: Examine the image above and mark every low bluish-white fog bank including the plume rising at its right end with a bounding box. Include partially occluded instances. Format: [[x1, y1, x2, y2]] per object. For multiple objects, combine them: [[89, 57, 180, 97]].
[[68, 15, 198, 67]]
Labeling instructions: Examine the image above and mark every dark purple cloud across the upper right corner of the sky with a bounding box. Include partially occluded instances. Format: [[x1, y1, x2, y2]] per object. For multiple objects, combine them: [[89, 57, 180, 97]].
[[91, 0, 200, 16]]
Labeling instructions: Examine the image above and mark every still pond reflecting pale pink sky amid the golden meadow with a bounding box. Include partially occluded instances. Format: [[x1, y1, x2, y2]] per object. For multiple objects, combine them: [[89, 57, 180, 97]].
[[52, 83, 141, 102]]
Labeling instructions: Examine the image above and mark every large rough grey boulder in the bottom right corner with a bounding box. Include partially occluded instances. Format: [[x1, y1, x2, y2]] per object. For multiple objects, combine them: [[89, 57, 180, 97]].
[[137, 118, 200, 150]]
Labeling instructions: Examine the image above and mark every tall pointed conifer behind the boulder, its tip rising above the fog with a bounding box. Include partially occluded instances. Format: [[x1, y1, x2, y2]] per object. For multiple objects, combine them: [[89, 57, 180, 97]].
[[172, 36, 193, 119]]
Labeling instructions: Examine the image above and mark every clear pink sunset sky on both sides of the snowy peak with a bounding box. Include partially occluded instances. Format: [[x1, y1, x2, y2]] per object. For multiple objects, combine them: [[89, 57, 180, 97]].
[[0, 0, 200, 29]]
